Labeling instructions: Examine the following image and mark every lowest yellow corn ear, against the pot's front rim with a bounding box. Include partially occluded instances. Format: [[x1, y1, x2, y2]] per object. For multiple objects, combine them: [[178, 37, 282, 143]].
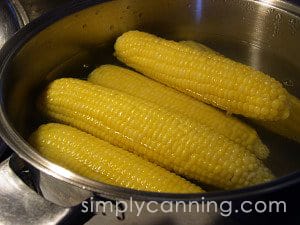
[[30, 123, 203, 193]]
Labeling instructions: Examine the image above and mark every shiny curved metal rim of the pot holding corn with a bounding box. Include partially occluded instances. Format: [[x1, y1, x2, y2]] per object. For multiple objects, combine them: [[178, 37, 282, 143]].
[[0, 0, 300, 202]]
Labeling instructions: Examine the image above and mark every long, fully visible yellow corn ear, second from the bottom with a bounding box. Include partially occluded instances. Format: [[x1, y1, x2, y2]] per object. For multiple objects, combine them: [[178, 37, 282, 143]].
[[40, 78, 273, 189]]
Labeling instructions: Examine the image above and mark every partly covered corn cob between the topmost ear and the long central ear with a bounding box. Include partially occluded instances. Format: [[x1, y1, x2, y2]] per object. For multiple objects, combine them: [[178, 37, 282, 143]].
[[88, 65, 269, 159]]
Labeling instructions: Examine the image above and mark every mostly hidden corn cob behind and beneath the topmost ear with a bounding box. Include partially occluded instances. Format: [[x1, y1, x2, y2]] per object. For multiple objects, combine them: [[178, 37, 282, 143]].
[[180, 41, 300, 143]]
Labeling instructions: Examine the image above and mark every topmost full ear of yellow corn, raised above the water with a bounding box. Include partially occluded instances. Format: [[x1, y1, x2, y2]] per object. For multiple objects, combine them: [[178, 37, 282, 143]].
[[115, 31, 289, 120]]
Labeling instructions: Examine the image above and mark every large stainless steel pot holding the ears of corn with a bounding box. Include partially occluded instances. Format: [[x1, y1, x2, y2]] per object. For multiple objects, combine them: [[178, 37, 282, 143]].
[[0, 0, 300, 224]]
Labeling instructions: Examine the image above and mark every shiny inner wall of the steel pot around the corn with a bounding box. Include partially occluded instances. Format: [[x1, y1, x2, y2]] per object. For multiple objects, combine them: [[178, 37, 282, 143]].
[[3, 0, 300, 179]]
